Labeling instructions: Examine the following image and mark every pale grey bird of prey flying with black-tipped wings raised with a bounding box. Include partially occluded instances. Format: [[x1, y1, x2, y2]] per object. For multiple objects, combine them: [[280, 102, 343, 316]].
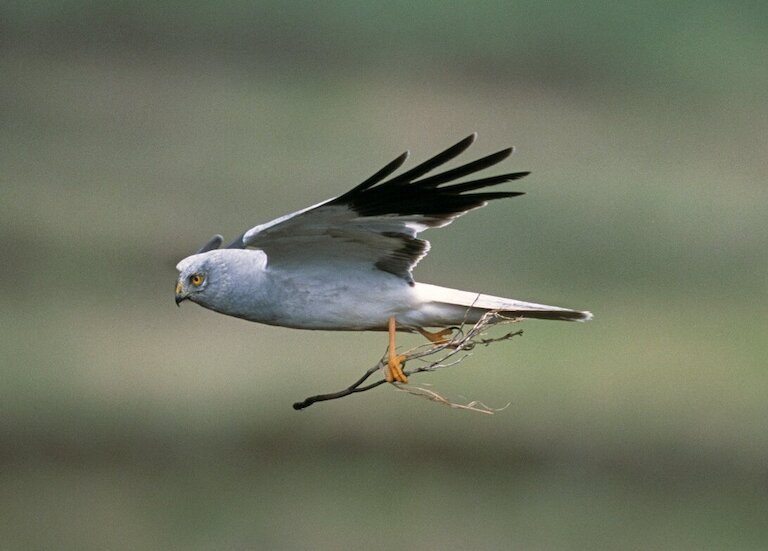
[[176, 134, 592, 383]]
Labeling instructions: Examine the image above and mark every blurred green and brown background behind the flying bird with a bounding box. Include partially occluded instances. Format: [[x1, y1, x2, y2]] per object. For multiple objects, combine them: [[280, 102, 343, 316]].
[[0, 0, 768, 550]]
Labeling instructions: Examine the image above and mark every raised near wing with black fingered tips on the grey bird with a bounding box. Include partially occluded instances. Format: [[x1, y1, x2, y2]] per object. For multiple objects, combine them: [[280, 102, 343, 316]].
[[229, 134, 529, 282]]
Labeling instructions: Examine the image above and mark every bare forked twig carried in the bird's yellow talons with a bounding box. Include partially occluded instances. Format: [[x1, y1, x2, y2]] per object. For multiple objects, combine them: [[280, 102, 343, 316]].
[[293, 312, 523, 414]]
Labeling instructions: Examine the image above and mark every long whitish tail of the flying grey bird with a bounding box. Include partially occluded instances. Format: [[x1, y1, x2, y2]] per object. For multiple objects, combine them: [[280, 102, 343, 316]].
[[408, 283, 592, 327]]
